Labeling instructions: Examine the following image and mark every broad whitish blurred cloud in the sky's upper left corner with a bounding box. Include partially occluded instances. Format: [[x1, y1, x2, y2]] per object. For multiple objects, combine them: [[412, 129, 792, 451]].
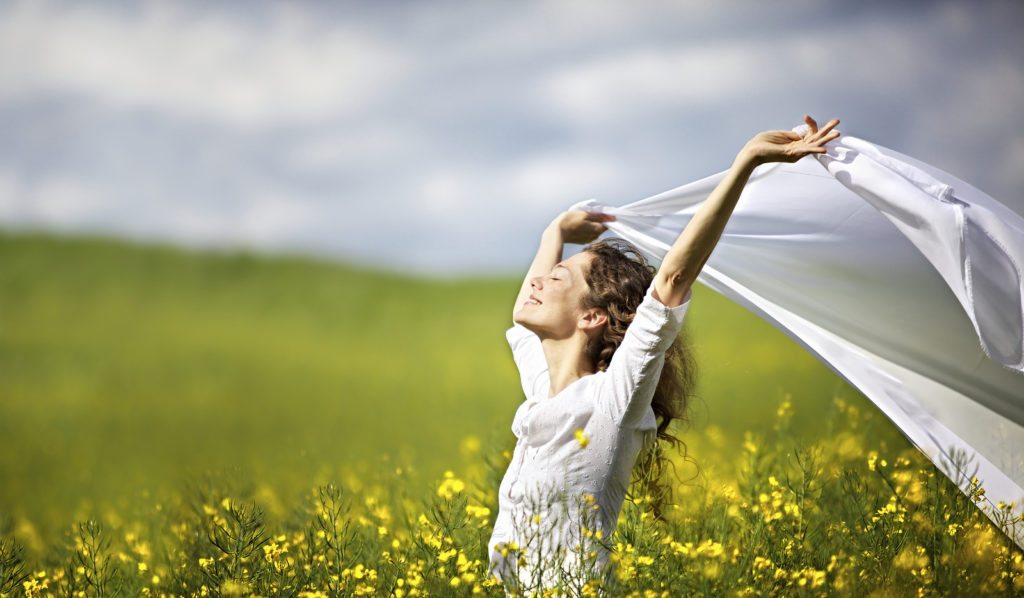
[[0, 3, 410, 127]]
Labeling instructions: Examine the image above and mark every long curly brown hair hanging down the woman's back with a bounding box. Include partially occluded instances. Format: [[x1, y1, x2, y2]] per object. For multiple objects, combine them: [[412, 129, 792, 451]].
[[582, 238, 697, 519]]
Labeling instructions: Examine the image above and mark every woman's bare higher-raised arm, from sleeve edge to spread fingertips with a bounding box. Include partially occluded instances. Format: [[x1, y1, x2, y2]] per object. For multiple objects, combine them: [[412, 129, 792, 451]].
[[655, 115, 839, 307]]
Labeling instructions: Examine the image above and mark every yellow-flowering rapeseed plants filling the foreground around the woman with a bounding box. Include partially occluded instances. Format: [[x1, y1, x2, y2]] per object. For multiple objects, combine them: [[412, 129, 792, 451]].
[[0, 395, 1024, 598]]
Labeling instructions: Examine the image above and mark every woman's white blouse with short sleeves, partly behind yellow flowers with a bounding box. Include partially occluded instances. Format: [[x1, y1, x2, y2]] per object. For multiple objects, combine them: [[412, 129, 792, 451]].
[[488, 282, 692, 586]]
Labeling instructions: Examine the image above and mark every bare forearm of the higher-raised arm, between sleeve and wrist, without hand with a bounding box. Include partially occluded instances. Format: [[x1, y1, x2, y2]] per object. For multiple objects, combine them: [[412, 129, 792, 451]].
[[657, 152, 758, 288]]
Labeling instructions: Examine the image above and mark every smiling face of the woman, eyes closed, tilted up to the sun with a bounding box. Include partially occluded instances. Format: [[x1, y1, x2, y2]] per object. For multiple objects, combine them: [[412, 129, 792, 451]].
[[512, 251, 594, 339]]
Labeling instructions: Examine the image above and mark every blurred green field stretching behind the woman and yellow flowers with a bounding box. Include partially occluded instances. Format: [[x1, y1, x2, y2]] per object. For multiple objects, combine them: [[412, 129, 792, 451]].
[[0, 226, 1019, 593]]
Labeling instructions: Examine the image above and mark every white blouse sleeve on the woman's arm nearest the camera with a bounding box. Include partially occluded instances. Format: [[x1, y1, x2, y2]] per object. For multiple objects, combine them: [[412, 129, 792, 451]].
[[597, 282, 693, 427]]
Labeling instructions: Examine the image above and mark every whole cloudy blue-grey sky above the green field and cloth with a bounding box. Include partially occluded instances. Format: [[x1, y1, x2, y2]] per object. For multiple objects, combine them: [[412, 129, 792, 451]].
[[0, 0, 1024, 277]]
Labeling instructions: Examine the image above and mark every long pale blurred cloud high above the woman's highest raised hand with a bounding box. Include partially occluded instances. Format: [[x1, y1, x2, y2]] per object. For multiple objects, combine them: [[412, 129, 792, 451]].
[[535, 25, 940, 130]]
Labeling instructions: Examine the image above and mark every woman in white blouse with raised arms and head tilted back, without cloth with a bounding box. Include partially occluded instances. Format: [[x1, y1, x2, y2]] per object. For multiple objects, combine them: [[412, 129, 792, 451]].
[[488, 116, 840, 589]]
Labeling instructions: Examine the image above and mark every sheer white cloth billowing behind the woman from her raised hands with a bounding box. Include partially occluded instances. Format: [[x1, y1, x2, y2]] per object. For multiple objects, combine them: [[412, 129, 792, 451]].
[[569, 125, 1024, 548]]
